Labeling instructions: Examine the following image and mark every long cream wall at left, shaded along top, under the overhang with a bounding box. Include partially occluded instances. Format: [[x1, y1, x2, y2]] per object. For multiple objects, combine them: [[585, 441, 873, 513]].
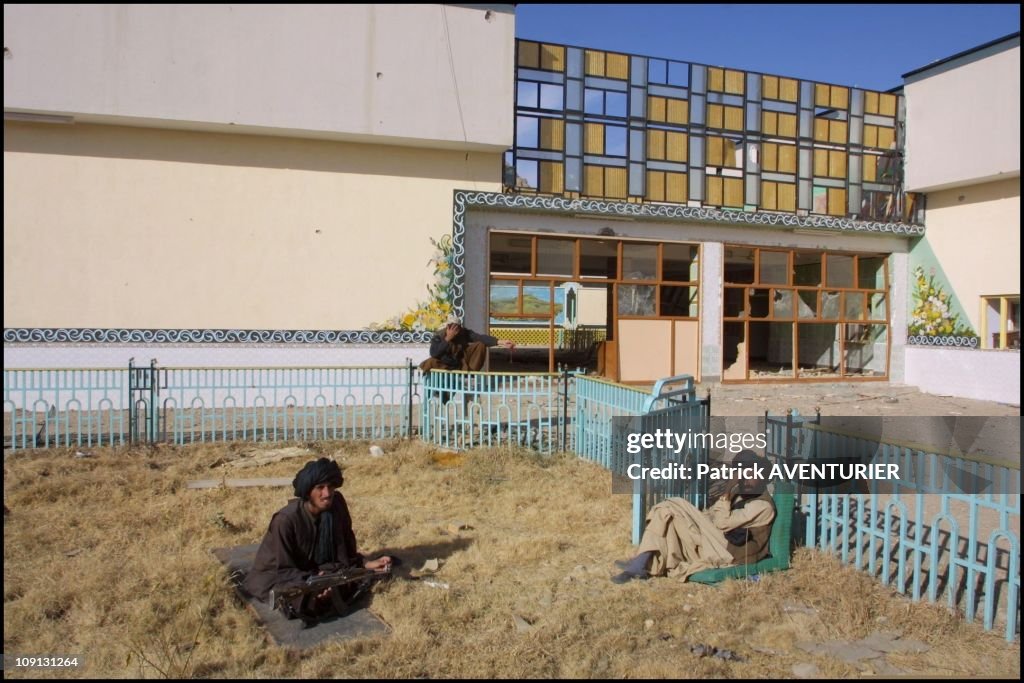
[[4, 122, 501, 330]]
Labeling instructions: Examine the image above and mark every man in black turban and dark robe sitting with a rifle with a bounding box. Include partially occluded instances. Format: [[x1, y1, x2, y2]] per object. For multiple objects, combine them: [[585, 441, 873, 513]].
[[242, 458, 392, 617]]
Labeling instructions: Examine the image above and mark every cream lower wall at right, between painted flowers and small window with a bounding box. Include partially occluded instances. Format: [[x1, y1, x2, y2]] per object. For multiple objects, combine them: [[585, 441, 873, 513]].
[[926, 178, 1021, 332]]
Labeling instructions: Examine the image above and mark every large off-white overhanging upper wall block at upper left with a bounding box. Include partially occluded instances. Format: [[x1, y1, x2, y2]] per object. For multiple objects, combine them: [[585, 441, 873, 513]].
[[3, 3, 515, 152]]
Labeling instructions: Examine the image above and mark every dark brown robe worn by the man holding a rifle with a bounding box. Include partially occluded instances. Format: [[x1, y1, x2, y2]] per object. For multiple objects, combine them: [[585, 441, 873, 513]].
[[242, 492, 364, 600]]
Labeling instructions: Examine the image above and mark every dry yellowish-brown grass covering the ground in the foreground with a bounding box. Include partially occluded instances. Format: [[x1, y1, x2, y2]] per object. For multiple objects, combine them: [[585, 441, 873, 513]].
[[4, 442, 1020, 678]]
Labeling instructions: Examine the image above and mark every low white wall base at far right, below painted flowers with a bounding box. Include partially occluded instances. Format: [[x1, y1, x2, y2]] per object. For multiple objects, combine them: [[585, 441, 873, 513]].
[[904, 346, 1021, 405]]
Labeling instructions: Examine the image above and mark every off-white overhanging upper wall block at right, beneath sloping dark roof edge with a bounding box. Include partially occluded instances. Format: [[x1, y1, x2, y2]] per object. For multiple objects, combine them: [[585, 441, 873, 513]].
[[904, 45, 1021, 192]]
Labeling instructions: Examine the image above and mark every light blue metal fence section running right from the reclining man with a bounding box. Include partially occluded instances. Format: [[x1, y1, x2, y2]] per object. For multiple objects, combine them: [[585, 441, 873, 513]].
[[768, 416, 1020, 640]]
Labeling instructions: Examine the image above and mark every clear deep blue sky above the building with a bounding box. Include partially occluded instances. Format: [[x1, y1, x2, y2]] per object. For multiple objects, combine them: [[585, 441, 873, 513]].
[[515, 3, 1021, 90]]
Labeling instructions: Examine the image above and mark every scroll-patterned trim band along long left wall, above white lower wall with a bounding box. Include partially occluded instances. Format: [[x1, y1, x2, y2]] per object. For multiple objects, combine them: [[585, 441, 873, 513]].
[[3, 328, 432, 344]]
